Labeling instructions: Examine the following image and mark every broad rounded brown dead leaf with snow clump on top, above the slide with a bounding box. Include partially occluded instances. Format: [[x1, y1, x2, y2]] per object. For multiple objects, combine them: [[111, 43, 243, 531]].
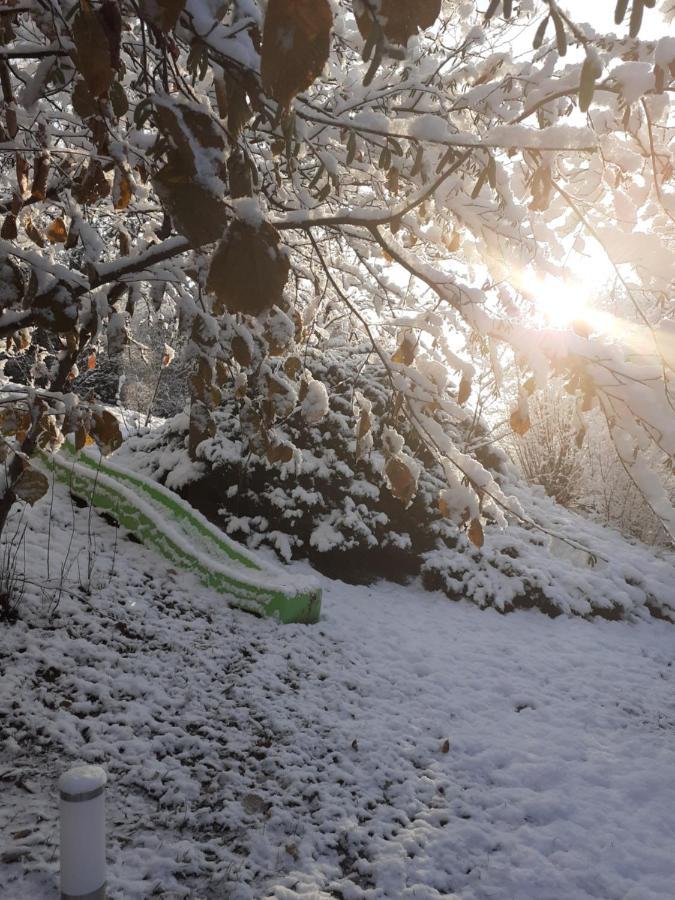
[[207, 219, 290, 316]]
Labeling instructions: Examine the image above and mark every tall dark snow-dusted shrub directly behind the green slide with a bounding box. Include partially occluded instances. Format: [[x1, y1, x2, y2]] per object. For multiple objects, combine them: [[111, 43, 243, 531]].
[[119, 345, 472, 582]]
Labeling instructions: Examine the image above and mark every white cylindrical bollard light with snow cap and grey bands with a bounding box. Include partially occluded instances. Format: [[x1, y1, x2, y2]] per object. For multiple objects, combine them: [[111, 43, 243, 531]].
[[59, 766, 108, 900]]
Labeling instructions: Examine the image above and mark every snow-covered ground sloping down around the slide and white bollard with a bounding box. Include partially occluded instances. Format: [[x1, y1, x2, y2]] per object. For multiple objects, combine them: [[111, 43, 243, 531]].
[[0, 488, 675, 900]]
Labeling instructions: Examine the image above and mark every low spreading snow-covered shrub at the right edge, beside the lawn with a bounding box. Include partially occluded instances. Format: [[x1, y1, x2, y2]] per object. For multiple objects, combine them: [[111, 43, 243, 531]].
[[421, 484, 675, 621]]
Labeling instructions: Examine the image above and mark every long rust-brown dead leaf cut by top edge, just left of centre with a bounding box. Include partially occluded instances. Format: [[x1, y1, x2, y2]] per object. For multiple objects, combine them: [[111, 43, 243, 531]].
[[260, 0, 333, 109]]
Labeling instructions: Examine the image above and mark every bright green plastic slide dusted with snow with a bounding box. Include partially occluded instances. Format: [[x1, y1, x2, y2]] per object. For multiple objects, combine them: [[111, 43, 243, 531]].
[[43, 443, 321, 624]]
